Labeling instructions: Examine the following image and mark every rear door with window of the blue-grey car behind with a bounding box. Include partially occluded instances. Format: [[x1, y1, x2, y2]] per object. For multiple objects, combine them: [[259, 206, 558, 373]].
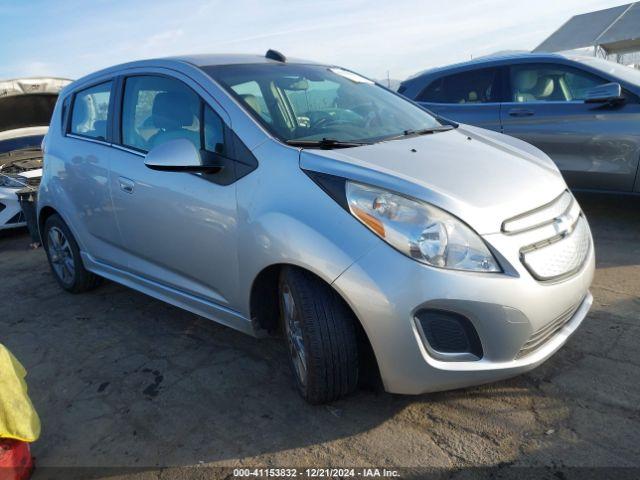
[[416, 67, 502, 131]]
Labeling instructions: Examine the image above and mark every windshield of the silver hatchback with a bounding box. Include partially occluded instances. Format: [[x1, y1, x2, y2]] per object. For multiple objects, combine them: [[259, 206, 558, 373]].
[[204, 64, 441, 143]]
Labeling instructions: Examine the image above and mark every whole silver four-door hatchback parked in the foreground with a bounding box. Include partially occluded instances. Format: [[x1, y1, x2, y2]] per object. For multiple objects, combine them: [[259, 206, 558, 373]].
[[38, 51, 594, 403]]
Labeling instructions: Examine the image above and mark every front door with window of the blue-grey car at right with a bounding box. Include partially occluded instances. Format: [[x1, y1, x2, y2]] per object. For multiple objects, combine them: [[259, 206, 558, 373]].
[[501, 63, 640, 191]]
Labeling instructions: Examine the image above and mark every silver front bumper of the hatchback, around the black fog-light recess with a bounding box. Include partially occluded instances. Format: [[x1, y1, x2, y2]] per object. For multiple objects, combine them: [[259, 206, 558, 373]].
[[334, 225, 595, 394]]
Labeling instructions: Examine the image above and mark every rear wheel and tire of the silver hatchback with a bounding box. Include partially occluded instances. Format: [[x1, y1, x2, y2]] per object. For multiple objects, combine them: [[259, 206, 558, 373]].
[[42, 214, 102, 293]]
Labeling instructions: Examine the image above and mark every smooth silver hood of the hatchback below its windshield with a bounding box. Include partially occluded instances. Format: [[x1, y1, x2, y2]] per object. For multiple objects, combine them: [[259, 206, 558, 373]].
[[300, 125, 567, 235]]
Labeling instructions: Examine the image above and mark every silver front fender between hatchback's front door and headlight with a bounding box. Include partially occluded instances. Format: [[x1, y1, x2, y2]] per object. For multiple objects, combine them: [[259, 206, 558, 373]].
[[237, 144, 381, 316]]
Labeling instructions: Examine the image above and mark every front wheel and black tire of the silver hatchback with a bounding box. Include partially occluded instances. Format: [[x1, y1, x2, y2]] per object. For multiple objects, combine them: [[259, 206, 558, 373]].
[[279, 267, 358, 404]]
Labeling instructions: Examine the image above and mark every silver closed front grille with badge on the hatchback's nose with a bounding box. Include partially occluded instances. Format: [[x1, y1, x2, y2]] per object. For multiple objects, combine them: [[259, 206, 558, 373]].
[[502, 191, 591, 282]]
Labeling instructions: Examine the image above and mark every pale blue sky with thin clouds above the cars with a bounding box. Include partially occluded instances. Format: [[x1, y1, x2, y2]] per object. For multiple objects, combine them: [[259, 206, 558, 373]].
[[0, 0, 629, 80]]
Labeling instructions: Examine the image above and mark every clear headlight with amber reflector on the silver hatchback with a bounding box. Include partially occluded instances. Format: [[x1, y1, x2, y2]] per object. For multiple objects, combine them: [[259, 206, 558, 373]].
[[346, 181, 501, 272]]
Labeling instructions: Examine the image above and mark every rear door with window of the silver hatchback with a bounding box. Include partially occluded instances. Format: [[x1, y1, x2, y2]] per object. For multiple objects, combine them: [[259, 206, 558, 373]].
[[61, 78, 127, 265]]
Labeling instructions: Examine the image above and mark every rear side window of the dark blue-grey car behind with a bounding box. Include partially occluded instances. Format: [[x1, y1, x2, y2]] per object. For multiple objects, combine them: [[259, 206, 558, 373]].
[[417, 68, 500, 104]]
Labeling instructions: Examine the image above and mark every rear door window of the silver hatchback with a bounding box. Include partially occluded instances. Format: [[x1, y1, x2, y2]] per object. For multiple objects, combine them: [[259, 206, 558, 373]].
[[69, 81, 112, 140]]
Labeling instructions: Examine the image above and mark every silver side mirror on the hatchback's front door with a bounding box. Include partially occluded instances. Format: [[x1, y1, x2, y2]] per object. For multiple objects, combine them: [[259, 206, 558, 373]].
[[144, 138, 224, 173]]
